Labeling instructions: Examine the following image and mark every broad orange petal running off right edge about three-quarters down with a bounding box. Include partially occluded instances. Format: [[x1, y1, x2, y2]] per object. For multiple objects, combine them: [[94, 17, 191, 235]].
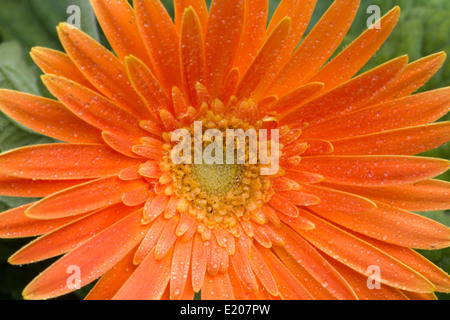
[[312, 202, 450, 249]]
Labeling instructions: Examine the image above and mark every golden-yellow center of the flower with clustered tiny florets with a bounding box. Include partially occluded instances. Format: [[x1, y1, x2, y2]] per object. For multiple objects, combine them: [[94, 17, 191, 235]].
[[162, 112, 273, 229]]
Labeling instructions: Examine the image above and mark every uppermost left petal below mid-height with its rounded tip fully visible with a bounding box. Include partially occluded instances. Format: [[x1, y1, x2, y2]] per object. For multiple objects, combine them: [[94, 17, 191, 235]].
[[26, 177, 147, 219]]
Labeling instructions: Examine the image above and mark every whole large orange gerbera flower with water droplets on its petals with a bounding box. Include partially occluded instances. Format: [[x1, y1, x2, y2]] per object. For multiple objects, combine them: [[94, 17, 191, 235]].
[[0, 0, 450, 299]]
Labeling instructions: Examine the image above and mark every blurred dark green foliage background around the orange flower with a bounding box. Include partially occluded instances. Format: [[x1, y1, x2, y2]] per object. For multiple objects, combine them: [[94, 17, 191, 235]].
[[0, 0, 450, 300]]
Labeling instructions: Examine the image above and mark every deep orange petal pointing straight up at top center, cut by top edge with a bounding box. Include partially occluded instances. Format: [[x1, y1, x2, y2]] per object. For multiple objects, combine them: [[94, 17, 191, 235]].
[[205, 0, 245, 98]]
